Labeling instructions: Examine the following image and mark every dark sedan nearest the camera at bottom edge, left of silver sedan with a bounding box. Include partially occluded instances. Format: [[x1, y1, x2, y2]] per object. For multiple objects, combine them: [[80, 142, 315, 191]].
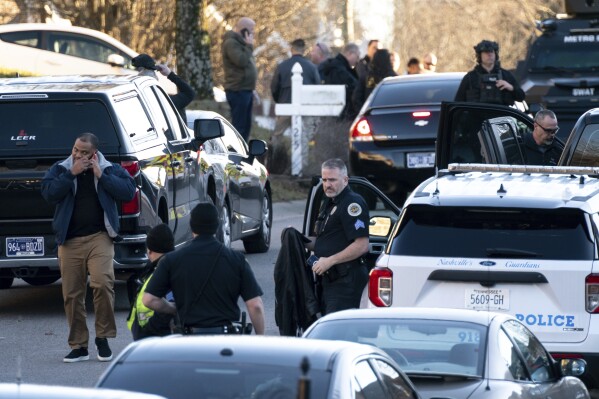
[[96, 335, 420, 399]]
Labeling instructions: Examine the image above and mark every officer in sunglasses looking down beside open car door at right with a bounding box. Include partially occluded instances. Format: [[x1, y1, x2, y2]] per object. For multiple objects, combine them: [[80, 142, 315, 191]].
[[523, 109, 564, 166]]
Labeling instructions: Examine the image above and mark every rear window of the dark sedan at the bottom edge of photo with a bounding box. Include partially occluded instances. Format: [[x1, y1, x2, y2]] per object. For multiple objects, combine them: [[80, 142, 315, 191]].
[[101, 361, 330, 399]]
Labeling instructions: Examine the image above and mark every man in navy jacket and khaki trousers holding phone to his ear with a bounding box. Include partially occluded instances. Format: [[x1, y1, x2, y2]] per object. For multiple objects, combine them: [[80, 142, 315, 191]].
[[42, 133, 136, 363]]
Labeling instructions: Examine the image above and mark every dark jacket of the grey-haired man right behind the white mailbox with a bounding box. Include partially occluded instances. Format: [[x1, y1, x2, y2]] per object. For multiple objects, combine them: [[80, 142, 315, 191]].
[[321, 54, 358, 120]]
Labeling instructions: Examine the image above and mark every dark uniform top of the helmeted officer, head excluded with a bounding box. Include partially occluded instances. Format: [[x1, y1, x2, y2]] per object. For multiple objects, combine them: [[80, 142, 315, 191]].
[[455, 65, 526, 105]]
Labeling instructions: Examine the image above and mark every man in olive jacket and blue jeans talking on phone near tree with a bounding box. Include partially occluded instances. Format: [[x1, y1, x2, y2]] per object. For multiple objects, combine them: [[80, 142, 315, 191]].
[[221, 17, 258, 141]]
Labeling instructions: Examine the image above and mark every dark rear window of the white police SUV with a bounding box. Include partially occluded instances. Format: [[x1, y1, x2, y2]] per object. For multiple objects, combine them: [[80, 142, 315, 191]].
[[390, 205, 595, 260]]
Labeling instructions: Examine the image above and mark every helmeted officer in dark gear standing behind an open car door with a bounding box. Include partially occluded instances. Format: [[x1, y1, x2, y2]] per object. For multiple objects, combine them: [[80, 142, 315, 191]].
[[455, 40, 525, 105]]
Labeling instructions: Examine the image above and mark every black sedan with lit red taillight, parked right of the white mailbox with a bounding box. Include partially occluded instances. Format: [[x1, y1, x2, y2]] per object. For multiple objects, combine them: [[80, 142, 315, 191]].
[[349, 72, 464, 205]]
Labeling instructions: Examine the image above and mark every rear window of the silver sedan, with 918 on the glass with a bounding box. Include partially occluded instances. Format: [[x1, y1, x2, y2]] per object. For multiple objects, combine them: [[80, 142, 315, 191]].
[[308, 318, 487, 377]]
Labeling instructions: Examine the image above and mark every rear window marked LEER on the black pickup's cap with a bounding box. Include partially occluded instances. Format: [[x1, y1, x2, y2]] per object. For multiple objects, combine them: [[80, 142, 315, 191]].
[[0, 100, 119, 156]]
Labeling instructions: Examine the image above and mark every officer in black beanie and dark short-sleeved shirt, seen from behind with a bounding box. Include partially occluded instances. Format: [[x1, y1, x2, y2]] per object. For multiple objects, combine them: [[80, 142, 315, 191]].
[[142, 203, 265, 335]]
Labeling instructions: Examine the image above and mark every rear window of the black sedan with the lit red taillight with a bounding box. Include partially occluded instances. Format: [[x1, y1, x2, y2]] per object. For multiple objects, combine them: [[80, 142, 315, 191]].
[[370, 79, 461, 107]]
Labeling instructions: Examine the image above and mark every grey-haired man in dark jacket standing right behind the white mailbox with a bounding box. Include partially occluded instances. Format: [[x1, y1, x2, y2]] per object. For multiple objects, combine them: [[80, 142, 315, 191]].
[[322, 43, 360, 121]]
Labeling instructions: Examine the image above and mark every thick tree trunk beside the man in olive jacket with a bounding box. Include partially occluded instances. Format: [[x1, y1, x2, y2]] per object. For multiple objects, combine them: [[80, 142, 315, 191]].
[[175, 0, 214, 99]]
